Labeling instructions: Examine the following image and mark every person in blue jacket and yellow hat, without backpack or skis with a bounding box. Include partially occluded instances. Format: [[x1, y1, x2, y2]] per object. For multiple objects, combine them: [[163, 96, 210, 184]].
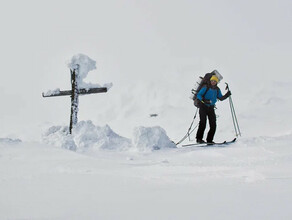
[[196, 75, 231, 144]]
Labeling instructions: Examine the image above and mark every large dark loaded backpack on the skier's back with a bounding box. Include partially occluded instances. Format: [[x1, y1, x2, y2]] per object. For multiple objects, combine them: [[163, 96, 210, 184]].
[[192, 70, 223, 108]]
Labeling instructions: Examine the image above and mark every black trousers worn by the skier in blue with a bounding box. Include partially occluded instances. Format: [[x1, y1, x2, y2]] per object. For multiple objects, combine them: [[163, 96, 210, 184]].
[[196, 104, 217, 142]]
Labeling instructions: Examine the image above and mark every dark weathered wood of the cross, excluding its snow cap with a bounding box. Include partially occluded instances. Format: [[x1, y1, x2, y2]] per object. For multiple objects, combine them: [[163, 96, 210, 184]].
[[42, 65, 107, 134]]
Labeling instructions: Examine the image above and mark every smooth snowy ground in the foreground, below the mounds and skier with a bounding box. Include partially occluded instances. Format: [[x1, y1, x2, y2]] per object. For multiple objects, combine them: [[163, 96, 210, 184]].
[[0, 134, 292, 219]]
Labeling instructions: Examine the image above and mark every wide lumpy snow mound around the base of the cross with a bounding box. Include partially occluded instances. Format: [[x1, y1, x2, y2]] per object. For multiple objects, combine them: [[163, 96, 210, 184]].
[[43, 121, 132, 152]]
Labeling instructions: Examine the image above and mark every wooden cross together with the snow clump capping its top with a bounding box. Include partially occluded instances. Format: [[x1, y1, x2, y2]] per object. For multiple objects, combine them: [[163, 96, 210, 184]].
[[42, 54, 112, 134]]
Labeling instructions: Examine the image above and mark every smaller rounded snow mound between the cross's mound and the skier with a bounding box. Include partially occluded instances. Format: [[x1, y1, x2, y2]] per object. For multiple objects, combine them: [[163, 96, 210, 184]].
[[134, 126, 176, 151]]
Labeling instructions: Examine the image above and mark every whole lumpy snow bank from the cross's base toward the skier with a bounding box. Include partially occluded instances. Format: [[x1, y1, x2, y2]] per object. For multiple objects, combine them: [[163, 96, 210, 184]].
[[43, 121, 176, 152]]
